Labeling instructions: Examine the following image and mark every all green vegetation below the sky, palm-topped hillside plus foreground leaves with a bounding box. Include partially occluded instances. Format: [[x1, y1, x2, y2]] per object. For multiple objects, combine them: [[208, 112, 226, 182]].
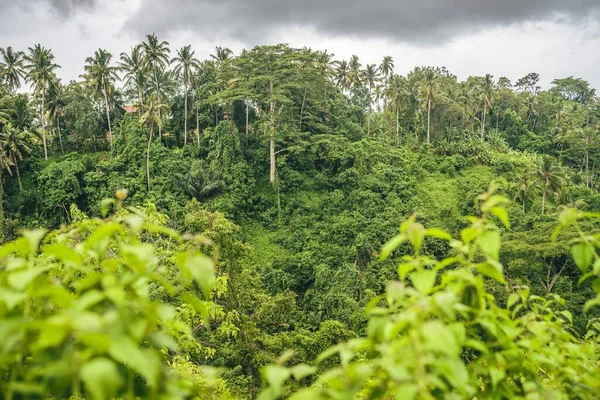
[[0, 34, 600, 399]]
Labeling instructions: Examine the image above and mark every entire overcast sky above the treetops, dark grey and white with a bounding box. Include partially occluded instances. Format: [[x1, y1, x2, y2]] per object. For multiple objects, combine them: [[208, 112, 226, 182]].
[[0, 0, 600, 89]]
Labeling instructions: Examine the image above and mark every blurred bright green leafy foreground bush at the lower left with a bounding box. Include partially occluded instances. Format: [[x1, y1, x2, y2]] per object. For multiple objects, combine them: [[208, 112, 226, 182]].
[[0, 192, 224, 400]]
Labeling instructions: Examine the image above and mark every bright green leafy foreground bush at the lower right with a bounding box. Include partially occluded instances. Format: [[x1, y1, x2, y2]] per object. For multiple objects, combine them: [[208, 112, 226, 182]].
[[260, 188, 600, 400]]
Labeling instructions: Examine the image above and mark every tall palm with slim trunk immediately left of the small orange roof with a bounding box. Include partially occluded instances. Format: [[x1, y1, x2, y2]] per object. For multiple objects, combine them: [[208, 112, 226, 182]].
[[84, 49, 119, 146]]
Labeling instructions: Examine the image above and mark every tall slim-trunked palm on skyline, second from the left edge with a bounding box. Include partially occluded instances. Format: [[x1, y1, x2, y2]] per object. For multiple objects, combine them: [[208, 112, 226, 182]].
[[23, 44, 60, 161]]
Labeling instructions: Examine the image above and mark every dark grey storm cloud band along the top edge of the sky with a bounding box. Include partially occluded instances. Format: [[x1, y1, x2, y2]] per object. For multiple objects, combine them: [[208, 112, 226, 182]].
[[124, 0, 600, 44]]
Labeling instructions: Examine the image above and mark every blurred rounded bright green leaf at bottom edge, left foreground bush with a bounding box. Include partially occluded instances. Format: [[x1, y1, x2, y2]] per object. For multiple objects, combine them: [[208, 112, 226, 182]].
[[81, 358, 123, 400]]
